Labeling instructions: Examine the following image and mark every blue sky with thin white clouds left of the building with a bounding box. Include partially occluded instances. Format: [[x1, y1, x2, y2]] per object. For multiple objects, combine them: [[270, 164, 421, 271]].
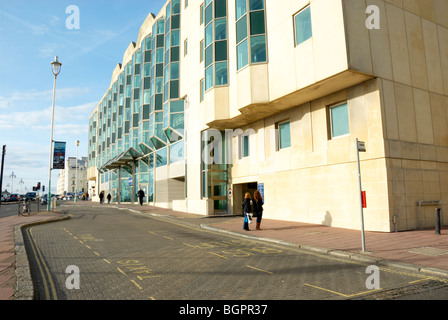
[[0, 0, 166, 192]]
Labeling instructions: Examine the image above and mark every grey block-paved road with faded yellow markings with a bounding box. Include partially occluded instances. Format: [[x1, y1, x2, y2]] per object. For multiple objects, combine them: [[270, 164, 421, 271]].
[[24, 206, 448, 300]]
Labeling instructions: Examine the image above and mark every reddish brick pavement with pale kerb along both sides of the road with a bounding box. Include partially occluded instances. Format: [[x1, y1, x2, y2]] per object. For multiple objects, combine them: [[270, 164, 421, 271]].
[[0, 201, 448, 300]]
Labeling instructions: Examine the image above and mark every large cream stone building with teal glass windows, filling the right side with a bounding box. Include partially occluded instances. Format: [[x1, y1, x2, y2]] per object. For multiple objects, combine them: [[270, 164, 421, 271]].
[[88, 0, 448, 232]]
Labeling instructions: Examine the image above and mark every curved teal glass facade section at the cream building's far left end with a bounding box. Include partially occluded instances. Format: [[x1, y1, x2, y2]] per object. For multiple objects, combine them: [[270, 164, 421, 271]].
[[89, 0, 185, 202]]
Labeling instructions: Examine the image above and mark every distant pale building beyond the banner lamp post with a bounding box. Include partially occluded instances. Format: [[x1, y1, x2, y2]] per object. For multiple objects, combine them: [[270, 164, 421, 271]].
[[57, 157, 87, 195]]
